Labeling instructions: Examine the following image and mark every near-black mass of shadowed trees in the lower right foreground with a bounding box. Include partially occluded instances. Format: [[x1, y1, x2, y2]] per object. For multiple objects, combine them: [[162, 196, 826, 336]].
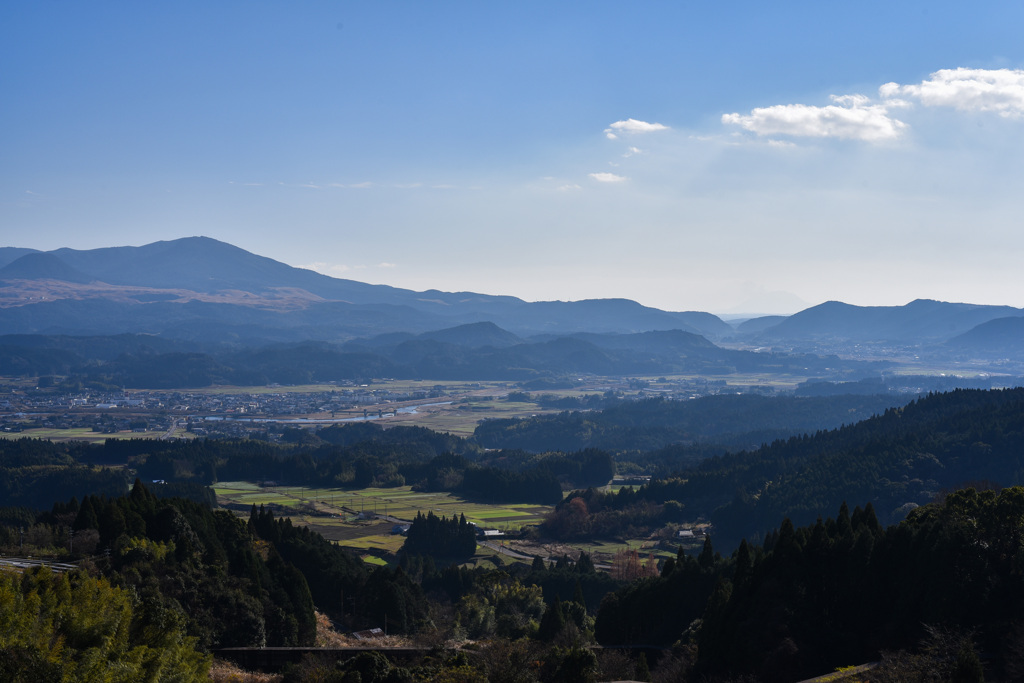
[[596, 487, 1024, 682]]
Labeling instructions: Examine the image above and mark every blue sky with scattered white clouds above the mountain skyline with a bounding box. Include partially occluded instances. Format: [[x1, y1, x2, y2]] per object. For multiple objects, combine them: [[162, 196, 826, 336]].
[[6, 0, 1024, 312]]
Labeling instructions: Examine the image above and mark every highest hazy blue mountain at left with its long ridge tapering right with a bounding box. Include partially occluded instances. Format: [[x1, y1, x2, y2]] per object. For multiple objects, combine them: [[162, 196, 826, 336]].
[[0, 238, 732, 342]]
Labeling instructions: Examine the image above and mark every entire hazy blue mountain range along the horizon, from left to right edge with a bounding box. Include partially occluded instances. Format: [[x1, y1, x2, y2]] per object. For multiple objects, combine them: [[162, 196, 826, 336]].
[[0, 237, 1024, 360]]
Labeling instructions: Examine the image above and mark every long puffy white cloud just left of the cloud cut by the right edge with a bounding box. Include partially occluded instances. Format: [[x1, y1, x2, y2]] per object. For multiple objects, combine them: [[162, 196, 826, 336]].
[[722, 95, 906, 142]]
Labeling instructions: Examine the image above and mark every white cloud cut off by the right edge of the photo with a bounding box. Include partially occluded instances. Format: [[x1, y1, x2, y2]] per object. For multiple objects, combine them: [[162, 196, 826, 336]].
[[879, 68, 1024, 118]]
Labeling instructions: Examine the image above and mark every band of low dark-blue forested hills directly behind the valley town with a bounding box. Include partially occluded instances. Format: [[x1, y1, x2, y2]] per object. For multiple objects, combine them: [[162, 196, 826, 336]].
[[0, 327, 868, 389]]
